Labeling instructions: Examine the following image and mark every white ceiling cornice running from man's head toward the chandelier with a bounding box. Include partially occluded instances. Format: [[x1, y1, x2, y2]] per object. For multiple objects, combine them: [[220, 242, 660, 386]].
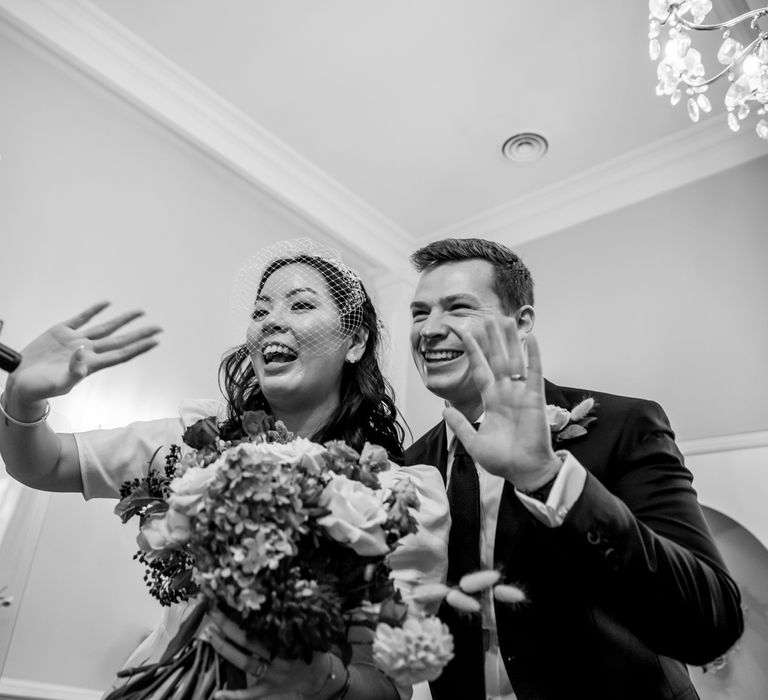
[[428, 118, 768, 245]]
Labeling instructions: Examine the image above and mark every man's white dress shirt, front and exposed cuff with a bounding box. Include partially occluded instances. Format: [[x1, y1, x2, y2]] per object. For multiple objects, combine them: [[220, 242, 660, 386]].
[[446, 414, 587, 700]]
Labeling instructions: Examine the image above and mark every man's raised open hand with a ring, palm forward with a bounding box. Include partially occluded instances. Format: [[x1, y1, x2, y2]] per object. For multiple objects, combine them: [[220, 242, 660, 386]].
[[443, 314, 560, 491]]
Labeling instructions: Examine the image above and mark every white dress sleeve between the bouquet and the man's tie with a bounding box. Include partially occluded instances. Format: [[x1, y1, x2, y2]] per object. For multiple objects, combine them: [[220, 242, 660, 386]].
[[379, 464, 451, 614]]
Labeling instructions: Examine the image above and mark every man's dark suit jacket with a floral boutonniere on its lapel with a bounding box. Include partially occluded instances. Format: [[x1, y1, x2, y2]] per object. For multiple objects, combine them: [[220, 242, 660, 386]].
[[406, 382, 743, 700]]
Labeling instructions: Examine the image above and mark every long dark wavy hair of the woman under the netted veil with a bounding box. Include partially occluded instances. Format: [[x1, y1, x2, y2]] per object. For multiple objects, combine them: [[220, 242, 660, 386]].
[[219, 255, 405, 463]]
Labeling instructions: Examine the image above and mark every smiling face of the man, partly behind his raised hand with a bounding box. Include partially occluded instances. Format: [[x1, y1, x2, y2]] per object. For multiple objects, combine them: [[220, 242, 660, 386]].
[[411, 258, 503, 414]]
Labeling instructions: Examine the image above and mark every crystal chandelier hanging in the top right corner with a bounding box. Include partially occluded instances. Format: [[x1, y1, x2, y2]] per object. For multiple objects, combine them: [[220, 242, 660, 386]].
[[648, 0, 768, 140]]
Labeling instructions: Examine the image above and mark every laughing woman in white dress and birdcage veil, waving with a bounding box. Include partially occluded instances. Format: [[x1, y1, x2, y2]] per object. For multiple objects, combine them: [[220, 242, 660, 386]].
[[0, 239, 449, 700]]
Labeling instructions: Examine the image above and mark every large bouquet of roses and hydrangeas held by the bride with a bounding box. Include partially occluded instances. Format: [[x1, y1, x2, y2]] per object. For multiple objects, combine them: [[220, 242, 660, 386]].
[[108, 411, 453, 700]]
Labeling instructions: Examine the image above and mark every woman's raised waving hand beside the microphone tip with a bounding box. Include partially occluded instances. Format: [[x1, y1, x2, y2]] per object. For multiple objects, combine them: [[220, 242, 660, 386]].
[[6, 302, 160, 405]]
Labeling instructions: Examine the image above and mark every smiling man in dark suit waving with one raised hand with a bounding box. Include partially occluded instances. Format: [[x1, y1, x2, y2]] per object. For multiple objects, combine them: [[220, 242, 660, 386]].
[[406, 239, 743, 700]]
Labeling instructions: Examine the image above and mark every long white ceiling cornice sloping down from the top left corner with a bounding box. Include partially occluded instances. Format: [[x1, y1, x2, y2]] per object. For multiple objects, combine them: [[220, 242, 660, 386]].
[[0, 0, 413, 270]]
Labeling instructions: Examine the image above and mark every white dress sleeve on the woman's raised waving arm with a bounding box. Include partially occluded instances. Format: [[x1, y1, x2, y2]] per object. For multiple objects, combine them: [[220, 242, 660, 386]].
[[74, 399, 221, 500]]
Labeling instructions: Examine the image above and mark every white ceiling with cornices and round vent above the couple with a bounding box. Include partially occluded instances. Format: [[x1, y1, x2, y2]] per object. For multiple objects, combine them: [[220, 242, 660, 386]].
[[0, 0, 768, 270]]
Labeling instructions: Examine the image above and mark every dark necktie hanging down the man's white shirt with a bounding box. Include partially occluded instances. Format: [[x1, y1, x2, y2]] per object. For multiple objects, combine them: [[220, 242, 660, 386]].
[[448, 432, 480, 585]]
